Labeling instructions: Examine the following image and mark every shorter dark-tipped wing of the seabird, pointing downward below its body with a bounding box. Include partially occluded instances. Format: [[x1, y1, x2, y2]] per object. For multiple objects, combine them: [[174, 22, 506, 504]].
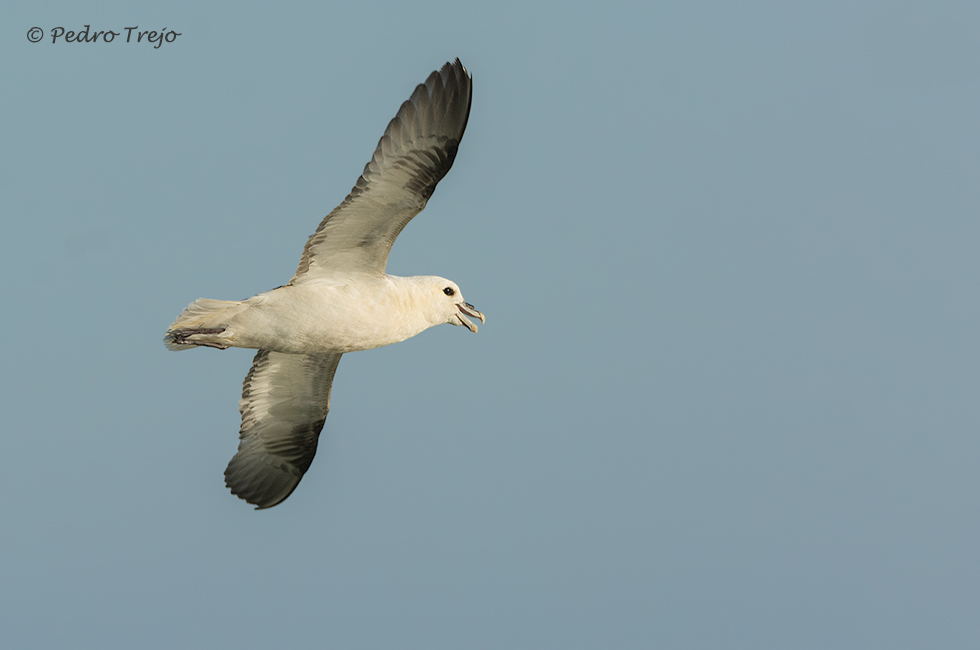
[[225, 350, 341, 508]]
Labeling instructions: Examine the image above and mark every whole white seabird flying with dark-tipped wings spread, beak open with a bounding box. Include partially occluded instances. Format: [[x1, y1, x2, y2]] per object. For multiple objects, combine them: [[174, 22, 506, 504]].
[[164, 59, 486, 508]]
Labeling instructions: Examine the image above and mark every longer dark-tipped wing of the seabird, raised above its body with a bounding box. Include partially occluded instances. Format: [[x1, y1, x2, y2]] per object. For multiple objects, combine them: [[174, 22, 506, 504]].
[[290, 59, 473, 282]]
